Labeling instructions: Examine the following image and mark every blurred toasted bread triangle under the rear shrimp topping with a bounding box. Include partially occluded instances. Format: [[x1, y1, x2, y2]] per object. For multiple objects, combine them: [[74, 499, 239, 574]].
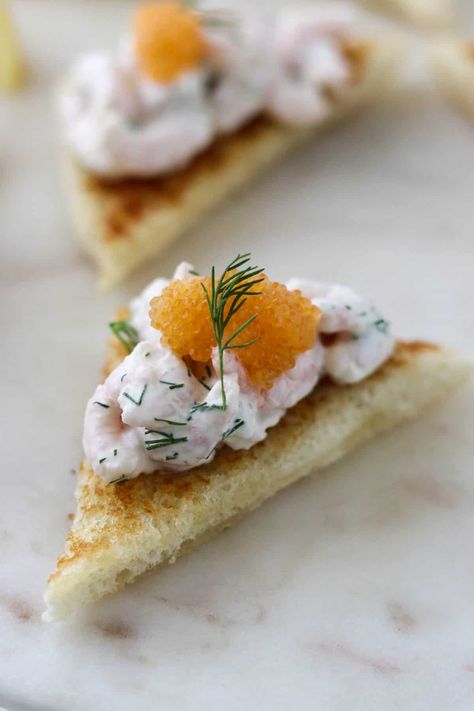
[[64, 41, 401, 289]]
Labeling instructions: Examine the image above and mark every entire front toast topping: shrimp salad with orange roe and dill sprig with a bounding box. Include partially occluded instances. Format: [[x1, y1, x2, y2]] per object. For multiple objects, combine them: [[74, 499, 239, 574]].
[[84, 255, 395, 483]]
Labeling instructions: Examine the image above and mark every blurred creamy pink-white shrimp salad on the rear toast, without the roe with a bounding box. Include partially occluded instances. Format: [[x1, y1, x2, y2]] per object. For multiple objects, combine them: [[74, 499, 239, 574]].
[[60, 4, 360, 178]]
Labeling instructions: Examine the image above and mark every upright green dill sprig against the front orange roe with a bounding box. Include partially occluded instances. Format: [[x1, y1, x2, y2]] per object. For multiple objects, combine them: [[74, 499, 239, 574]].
[[201, 253, 264, 410]]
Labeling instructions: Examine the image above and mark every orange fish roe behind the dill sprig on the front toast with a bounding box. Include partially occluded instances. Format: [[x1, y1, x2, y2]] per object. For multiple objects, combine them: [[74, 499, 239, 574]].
[[150, 277, 320, 388]]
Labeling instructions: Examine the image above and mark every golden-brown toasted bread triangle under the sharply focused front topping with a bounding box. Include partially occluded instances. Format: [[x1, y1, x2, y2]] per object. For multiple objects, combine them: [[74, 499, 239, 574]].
[[44, 343, 471, 621]]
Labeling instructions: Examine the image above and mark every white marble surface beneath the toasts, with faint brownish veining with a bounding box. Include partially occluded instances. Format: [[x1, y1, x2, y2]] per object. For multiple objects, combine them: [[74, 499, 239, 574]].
[[0, 0, 474, 711]]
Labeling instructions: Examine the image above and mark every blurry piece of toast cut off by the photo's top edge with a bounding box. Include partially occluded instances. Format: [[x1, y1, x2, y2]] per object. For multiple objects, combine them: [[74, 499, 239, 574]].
[[360, 0, 455, 31]]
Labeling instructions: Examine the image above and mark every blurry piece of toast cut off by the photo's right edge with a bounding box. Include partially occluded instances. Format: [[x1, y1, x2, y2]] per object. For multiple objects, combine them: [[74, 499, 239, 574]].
[[430, 37, 474, 120]]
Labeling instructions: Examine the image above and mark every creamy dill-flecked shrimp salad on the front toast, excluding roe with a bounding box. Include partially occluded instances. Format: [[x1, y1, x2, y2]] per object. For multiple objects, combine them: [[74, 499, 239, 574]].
[[84, 262, 394, 482]]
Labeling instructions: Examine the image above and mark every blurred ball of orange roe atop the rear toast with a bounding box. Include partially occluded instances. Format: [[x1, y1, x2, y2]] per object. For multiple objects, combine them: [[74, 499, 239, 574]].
[[133, 1, 204, 83]]
